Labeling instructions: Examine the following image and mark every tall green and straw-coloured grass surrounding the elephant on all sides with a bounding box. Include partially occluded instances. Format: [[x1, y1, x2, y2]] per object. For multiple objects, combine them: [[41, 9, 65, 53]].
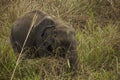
[[0, 0, 120, 80]]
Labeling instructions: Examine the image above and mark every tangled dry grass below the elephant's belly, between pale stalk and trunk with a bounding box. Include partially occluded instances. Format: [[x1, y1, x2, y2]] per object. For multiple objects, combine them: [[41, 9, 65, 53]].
[[14, 57, 70, 80]]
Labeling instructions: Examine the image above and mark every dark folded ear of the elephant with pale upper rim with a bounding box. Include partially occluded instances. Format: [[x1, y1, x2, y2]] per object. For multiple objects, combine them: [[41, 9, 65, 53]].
[[37, 16, 55, 37]]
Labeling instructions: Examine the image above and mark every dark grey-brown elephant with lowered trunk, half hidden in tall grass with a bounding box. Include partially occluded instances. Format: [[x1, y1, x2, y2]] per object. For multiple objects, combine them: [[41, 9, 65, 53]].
[[10, 10, 78, 69]]
